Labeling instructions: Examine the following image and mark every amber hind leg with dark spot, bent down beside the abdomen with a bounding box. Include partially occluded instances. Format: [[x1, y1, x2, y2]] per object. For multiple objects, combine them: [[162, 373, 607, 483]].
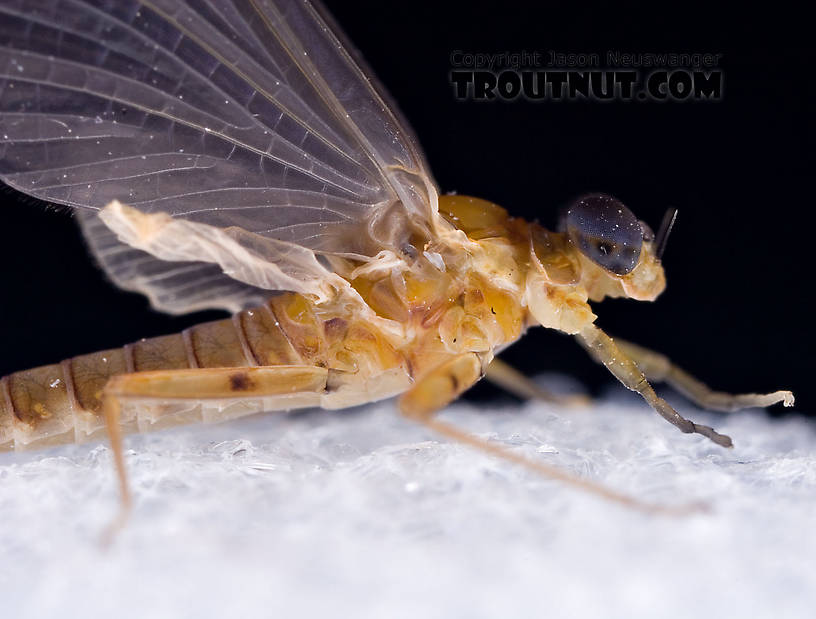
[[102, 365, 328, 529]]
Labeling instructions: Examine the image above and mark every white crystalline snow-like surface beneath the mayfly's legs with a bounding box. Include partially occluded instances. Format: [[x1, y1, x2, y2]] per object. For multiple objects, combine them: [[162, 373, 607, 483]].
[[0, 378, 816, 619]]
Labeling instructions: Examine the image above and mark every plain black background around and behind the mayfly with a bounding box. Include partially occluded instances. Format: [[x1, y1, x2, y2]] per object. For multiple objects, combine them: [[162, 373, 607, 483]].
[[0, 1, 816, 412]]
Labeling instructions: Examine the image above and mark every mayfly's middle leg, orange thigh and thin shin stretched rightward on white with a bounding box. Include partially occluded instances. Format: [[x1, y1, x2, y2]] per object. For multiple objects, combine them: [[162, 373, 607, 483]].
[[400, 353, 701, 515]]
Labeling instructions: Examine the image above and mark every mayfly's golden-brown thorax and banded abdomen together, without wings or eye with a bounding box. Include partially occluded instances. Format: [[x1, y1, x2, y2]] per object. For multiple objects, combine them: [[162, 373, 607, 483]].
[[0, 196, 632, 448]]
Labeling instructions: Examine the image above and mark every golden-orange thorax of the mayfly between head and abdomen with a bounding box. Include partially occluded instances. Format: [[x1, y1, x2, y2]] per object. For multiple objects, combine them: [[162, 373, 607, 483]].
[[300, 196, 664, 388]]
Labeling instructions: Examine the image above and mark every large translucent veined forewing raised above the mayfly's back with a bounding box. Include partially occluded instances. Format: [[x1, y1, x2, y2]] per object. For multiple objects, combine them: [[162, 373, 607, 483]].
[[0, 0, 436, 309]]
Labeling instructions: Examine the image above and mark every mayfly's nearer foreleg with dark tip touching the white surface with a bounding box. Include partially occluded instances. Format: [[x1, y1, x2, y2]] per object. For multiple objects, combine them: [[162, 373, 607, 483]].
[[578, 325, 733, 447]]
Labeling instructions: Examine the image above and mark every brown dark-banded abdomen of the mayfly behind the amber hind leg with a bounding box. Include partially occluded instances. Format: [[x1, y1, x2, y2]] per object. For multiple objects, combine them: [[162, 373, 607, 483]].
[[0, 294, 336, 451]]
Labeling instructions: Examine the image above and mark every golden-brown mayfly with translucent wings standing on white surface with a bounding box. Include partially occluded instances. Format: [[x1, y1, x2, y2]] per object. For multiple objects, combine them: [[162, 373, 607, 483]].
[[0, 0, 793, 520]]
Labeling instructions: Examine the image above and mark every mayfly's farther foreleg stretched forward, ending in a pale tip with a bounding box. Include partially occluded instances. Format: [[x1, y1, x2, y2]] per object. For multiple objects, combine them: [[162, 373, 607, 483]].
[[615, 338, 794, 413]]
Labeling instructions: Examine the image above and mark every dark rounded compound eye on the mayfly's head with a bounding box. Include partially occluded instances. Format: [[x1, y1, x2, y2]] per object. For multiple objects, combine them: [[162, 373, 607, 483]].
[[562, 193, 644, 275]]
